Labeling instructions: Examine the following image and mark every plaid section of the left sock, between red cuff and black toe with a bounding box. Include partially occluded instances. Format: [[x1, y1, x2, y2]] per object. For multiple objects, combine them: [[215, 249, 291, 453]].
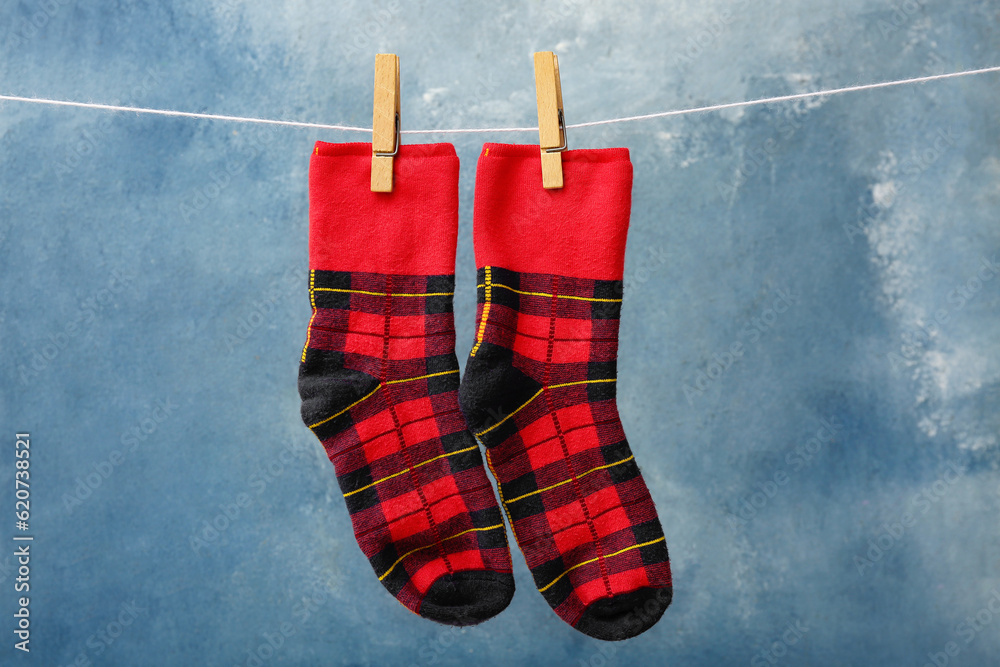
[[299, 271, 511, 613]]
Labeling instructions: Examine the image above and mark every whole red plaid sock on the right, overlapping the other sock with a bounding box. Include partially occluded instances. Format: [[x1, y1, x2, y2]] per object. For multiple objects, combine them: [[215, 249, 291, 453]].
[[460, 144, 672, 639]]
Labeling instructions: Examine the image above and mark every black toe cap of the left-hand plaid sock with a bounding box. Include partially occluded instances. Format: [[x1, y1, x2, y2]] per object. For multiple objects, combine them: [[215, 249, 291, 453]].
[[419, 570, 514, 625]]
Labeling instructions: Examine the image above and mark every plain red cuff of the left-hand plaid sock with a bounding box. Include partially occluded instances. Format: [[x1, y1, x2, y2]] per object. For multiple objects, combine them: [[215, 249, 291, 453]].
[[309, 141, 459, 275]]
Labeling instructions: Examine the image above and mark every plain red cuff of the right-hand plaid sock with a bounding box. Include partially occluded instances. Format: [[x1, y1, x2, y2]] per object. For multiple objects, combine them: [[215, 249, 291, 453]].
[[474, 144, 632, 280]]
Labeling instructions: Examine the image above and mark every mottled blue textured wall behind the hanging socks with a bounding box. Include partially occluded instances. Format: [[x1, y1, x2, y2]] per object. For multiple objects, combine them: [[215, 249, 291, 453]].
[[0, 0, 1000, 666]]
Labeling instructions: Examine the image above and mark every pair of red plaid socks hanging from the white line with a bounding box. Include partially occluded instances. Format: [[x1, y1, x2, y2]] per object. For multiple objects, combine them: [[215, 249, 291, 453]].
[[299, 142, 672, 640]]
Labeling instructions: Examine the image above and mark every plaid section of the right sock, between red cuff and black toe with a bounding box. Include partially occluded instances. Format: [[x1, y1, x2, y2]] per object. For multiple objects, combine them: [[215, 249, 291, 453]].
[[461, 266, 671, 625]]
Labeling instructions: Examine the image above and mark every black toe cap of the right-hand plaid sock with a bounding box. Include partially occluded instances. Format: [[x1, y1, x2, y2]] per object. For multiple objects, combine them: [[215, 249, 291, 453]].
[[573, 588, 673, 641]]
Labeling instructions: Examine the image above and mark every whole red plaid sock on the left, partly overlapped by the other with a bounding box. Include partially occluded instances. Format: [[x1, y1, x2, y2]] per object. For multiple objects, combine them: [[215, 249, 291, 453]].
[[299, 142, 514, 625]]
